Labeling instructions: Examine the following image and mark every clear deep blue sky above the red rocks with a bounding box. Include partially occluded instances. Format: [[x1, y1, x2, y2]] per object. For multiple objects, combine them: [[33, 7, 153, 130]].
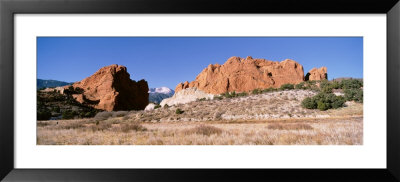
[[37, 37, 363, 89]]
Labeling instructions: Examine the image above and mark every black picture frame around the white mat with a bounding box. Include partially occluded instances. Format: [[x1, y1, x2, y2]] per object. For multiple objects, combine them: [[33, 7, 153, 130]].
[[0, 0, 400, 181]]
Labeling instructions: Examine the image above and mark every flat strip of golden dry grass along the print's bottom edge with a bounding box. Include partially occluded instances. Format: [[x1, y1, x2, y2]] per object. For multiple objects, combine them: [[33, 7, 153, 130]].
[[37, 116, 363, 145]]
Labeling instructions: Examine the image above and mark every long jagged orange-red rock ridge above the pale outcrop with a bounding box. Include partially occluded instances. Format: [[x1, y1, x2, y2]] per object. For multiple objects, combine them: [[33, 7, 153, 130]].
[[175, 57, 304, 94]]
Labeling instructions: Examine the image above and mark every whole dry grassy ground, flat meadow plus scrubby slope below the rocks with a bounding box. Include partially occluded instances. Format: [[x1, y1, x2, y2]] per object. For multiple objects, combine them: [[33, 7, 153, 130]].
[[37, 90, 363, 145]]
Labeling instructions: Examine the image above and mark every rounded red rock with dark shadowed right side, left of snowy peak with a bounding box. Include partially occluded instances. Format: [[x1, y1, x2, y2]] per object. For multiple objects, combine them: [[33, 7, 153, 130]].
[[68, 64, 149, 111]]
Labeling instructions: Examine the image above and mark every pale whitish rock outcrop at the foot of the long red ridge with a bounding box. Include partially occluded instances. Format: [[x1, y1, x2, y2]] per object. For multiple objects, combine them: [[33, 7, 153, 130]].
[[160, 87, 214, 107]]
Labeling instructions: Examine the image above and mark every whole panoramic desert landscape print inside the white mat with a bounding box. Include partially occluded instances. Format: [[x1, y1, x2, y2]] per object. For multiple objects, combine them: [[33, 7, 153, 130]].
[[36, 37, 363, 145]]
